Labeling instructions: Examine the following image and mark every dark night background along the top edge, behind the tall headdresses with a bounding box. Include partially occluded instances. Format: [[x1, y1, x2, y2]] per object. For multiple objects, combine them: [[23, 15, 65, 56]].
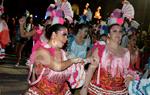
[[4, 0, 150, 30]]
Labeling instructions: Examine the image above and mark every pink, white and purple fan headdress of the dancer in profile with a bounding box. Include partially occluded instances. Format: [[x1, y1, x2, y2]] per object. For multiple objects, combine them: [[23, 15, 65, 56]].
[[45, 0, 73, 24]]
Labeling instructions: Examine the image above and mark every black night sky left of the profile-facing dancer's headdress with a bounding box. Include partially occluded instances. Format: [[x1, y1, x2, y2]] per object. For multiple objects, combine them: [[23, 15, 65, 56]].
[[4, 0, 52, 16]]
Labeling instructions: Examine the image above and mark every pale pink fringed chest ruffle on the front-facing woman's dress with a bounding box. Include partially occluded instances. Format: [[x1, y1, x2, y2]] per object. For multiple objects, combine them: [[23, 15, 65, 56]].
[[101, 48, 130, 77]]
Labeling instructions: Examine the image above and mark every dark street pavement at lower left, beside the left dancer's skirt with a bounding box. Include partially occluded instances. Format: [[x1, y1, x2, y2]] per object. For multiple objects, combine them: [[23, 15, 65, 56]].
[[0, 55, 28, 95]]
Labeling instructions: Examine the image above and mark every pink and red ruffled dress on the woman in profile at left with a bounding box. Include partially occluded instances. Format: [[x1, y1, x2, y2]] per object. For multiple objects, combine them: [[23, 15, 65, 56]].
[[26, 41, 85, 95]]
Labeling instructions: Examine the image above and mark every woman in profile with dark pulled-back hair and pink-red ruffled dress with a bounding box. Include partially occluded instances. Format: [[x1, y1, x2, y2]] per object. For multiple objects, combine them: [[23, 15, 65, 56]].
[[25, 24, 85, 95]]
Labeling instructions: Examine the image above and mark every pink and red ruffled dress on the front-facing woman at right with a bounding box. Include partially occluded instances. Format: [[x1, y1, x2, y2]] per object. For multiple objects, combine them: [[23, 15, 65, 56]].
[[88, 42, 136, 95]]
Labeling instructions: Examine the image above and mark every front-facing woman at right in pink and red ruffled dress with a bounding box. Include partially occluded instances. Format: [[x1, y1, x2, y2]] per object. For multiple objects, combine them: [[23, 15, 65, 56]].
[[80, 24, 138, 95]]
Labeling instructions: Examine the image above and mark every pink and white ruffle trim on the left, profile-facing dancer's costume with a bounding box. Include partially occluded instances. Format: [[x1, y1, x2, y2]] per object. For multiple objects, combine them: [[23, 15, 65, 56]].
[[28, 41, 85, 88]]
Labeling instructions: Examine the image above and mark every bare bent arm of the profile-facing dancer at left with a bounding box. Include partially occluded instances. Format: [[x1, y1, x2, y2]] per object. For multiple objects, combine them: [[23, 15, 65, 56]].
[[35, 49, 82, 71]]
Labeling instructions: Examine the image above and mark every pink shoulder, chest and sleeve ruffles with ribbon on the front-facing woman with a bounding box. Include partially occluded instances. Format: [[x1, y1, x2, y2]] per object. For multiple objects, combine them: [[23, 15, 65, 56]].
[[92, 42, 139, 84]]
